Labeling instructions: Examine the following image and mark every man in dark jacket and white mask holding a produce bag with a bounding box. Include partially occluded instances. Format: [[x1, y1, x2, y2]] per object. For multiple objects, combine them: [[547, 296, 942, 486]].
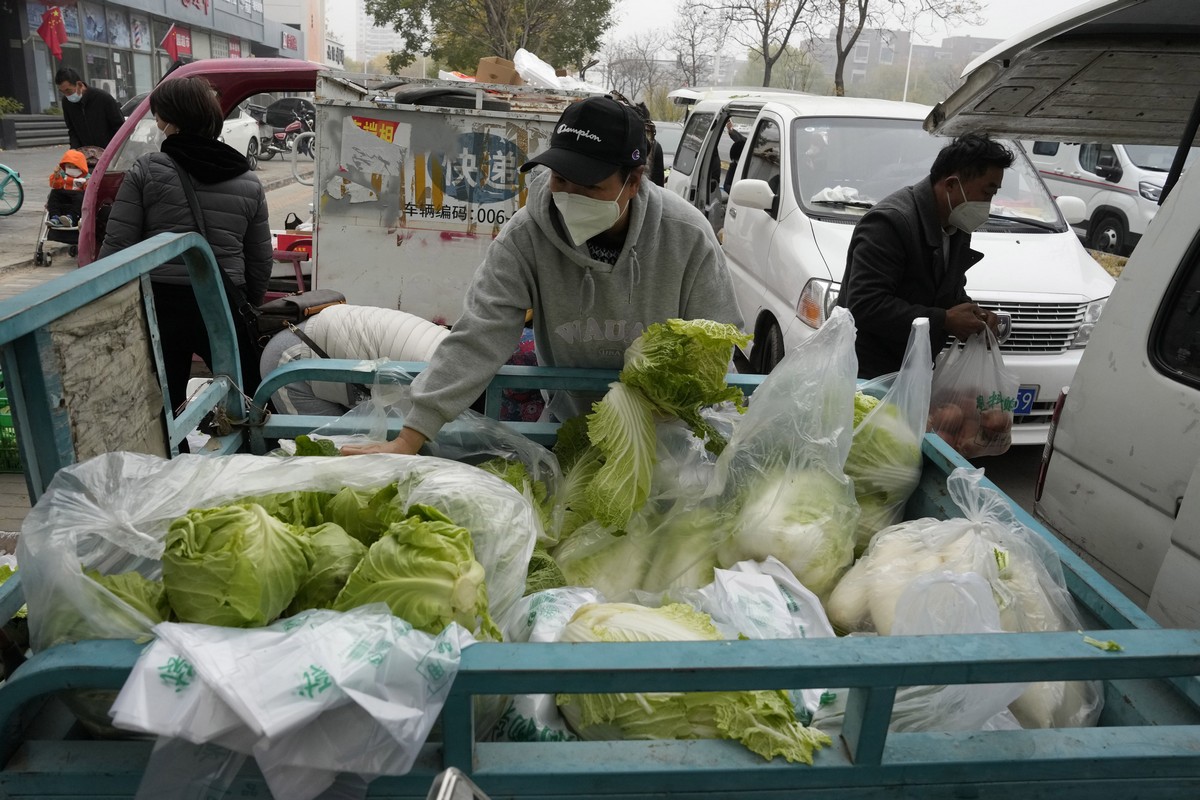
[[838, 133, 1013, 378]]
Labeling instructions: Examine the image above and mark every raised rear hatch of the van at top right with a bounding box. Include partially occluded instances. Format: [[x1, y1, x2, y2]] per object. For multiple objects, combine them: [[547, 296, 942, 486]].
[[925, 0, 1200, 151]]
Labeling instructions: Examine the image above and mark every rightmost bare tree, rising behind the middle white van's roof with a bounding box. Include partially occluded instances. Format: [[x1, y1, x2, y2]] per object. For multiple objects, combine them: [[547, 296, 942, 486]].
[[816, 0, 982, 96]]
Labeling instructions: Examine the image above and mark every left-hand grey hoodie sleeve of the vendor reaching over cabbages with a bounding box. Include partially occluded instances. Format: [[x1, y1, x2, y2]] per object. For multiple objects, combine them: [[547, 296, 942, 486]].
[[404, 236, 533, 439]]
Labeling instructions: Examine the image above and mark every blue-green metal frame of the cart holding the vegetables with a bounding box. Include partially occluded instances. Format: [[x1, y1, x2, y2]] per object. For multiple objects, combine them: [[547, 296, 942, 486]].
[[0, 235, 1200, 799]]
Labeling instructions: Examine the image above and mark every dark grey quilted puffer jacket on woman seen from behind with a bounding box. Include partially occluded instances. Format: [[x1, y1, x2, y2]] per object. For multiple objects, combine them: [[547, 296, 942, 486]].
[[100, 133, 272, 305]]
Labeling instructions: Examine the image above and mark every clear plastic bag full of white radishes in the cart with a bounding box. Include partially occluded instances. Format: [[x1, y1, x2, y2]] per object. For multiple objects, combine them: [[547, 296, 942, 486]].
[[826, 469, 1103, 728]]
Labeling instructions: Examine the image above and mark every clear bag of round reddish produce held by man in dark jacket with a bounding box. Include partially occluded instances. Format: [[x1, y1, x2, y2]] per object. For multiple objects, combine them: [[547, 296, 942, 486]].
[[929, 327, 1020, 458]]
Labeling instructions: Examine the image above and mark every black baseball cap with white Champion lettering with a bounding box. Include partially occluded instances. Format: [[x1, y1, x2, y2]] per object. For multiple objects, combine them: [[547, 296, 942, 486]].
[[521, 96, 646, 186]]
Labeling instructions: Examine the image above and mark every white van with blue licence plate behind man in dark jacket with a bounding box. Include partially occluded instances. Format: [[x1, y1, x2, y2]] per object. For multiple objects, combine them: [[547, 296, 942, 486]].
[[667, 94, 1112, 444]]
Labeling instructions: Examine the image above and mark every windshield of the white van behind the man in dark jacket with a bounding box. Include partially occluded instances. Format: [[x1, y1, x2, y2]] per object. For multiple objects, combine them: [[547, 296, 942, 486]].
[[792, 118, 1067, 231]]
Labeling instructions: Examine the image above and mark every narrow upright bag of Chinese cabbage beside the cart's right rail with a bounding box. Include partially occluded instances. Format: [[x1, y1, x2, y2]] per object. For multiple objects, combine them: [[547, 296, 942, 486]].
[[846, 318, 934, 554]]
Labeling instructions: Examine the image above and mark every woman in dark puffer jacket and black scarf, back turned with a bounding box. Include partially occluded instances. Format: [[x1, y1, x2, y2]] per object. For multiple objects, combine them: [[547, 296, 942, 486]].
[[100, 78, 272, 419]]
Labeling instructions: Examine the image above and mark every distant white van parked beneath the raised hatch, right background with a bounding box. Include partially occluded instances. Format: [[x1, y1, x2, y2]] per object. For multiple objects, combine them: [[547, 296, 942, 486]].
[[1021, 139, 1192, 255]]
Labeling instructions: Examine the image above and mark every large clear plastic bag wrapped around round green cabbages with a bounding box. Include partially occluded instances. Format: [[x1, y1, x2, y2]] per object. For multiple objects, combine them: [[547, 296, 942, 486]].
[[18, 452, 539, 650]]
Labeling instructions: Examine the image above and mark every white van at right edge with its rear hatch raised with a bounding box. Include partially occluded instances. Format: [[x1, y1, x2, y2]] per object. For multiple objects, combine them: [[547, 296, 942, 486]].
[[926, 0, 1200, 627]]
